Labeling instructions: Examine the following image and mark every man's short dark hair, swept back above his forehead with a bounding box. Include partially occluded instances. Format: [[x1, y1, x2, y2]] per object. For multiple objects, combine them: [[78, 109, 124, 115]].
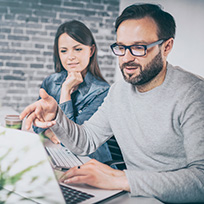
[[115, 4, 176, 40]]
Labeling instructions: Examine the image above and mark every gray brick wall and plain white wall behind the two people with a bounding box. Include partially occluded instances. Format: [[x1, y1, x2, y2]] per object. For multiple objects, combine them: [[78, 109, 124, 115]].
[[0, 0, 204, 112]]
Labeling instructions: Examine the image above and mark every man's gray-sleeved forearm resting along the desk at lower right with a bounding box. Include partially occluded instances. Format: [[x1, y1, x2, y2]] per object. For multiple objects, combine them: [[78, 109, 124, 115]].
[[125, 168, 204, 203]]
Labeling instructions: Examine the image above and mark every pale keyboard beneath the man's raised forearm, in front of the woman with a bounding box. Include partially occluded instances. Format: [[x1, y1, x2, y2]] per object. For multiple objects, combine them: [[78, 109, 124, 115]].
[[45, 145, 82, 169]]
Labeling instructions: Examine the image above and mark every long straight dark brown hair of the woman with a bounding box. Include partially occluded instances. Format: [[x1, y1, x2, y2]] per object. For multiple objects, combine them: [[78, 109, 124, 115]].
[[54, 20, 105, 81]]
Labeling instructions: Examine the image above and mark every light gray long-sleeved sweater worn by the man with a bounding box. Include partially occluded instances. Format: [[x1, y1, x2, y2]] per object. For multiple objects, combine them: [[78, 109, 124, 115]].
[[52, 64, 204, 203]]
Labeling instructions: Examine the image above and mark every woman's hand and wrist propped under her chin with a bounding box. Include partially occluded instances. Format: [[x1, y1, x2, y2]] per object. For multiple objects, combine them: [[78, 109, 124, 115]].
[[60, 72, 83, 104]]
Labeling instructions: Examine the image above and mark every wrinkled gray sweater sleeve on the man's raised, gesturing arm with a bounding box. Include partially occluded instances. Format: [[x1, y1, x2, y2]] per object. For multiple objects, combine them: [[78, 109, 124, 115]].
[[51, 91, 113, 155]]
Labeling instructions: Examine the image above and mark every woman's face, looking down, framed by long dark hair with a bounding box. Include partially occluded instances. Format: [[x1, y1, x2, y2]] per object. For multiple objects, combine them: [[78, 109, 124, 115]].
[[58, 33, 95, 74]]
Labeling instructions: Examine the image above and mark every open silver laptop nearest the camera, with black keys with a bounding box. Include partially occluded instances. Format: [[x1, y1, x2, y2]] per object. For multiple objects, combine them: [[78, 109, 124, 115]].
[[0, 126, 124, 204]]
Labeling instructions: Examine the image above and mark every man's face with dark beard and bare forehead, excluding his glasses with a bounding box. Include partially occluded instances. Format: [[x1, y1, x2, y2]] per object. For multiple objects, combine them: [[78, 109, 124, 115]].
[[117, 18, 164, 86]]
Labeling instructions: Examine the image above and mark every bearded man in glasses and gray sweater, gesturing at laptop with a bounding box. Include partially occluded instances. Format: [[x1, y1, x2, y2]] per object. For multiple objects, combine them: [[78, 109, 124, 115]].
[[21, 4, 204, 203]]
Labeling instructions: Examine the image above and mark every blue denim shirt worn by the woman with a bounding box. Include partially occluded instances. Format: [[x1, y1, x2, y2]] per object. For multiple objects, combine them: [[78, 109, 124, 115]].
[[33, 70, 112, 162]]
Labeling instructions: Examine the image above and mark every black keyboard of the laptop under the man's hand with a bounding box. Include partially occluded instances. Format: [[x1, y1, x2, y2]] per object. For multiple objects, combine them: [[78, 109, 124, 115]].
[[60, 185, 94, 204]]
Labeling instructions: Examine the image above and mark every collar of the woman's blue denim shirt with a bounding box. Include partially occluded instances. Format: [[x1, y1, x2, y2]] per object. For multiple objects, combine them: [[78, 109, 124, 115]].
[[54, 70, 93, 96]]
